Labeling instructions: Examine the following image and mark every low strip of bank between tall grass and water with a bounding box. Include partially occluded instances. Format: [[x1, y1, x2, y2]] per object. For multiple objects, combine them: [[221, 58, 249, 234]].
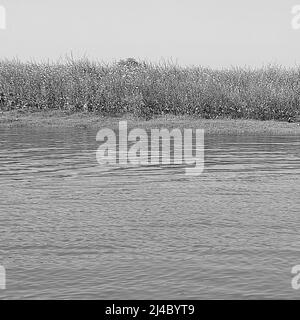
[[0, 110, 300, 135]]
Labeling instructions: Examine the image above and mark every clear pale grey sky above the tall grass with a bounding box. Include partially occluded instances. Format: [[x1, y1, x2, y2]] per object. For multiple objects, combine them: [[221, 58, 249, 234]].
[[0, 0, 300, 68]]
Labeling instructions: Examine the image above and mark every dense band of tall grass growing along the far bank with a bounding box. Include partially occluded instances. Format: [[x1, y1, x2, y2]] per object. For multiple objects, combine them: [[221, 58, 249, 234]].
[[0, 59, 300, 121]]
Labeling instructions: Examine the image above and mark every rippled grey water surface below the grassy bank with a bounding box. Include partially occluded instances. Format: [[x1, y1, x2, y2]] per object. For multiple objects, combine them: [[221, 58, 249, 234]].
[[0, 128, 300, 299]]
